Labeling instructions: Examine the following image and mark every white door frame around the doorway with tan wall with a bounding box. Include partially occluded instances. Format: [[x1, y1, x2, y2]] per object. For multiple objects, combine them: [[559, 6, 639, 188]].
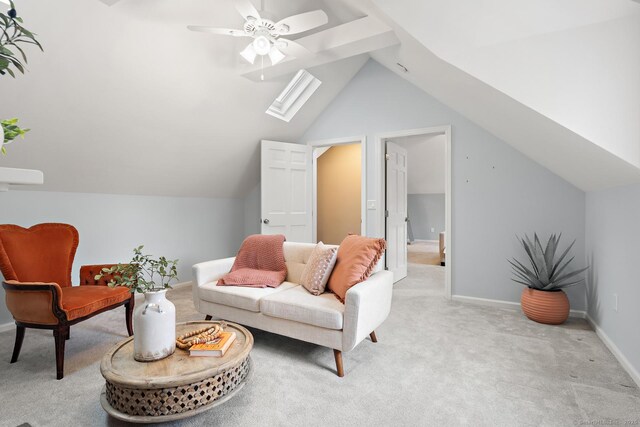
[[307, 135, 367, 242]]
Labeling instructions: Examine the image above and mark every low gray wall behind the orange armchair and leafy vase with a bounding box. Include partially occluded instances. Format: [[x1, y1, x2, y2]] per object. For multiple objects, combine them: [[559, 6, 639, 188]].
[[0, 190, 244, 324]]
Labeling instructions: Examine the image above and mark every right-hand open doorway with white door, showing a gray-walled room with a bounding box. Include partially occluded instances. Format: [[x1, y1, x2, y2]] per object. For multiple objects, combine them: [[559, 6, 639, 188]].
[[377, 126, 452, 298]]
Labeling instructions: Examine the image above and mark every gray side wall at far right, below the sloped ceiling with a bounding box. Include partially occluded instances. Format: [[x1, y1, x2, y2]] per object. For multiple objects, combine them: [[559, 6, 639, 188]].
[[586, 184, 640, 380]]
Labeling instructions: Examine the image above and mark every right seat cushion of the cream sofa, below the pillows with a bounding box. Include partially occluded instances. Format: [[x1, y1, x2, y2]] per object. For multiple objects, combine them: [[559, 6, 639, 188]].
[[260, 286, 344, 330]]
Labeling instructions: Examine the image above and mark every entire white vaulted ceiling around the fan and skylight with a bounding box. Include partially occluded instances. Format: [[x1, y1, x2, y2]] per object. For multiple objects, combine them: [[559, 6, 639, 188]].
[[0, 0, 640, 197]]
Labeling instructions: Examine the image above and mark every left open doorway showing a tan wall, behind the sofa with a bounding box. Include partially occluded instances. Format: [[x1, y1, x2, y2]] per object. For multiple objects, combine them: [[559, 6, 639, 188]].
[[310, 138, 366, 245]]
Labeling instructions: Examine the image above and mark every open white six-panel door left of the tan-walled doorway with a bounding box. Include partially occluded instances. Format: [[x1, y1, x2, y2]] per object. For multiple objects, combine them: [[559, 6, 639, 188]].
[[261, 141, 312, 242]]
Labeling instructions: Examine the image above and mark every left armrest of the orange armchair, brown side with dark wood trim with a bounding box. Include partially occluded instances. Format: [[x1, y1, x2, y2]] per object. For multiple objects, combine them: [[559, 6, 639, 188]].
[[2, 280, 67, 325]]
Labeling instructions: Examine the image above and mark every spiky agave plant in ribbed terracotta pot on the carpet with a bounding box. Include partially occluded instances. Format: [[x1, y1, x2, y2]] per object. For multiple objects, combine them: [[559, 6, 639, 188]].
[[509, 233, 588, 325]]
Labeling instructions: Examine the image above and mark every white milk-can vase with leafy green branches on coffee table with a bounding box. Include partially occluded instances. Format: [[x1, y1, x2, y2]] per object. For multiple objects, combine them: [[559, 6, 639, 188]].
[[95, 246, 178, 362]]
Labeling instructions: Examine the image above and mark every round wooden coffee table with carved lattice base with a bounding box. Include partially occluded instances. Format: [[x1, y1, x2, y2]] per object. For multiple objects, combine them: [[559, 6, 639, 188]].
[[100, 322, 253, 423]]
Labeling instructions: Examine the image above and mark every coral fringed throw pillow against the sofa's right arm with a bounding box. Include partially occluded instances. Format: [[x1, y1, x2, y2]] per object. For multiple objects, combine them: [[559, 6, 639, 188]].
[[327, 235, 387, 303]]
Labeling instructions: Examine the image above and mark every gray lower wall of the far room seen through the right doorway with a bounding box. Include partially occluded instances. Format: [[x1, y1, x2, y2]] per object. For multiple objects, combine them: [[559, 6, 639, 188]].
[[407, 194, 445, 240]]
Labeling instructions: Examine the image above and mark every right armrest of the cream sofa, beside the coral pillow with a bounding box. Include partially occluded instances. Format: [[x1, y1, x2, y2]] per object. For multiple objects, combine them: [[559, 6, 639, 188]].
[[342, 271, 393, 351]]
